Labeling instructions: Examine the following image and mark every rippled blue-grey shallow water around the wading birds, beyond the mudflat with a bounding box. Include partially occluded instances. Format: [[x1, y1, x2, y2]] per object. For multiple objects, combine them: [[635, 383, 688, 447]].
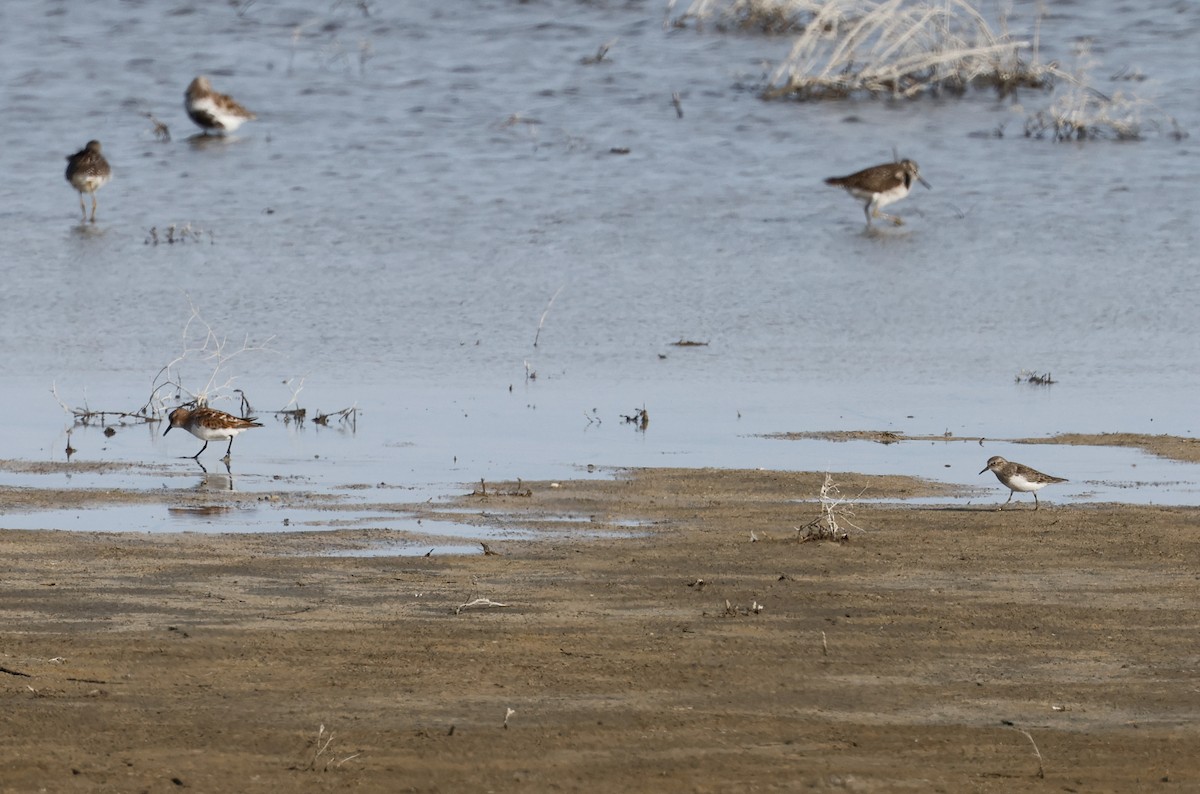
[[0, 0, 1200, 531]]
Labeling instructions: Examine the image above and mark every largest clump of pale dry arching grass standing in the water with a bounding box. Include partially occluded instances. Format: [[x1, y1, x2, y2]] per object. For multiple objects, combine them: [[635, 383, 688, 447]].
[[763, 0, 1061, 100]]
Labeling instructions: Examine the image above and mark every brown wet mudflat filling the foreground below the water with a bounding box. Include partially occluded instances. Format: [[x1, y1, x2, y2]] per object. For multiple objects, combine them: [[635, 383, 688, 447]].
[[0, 469, 1200, 792]]
